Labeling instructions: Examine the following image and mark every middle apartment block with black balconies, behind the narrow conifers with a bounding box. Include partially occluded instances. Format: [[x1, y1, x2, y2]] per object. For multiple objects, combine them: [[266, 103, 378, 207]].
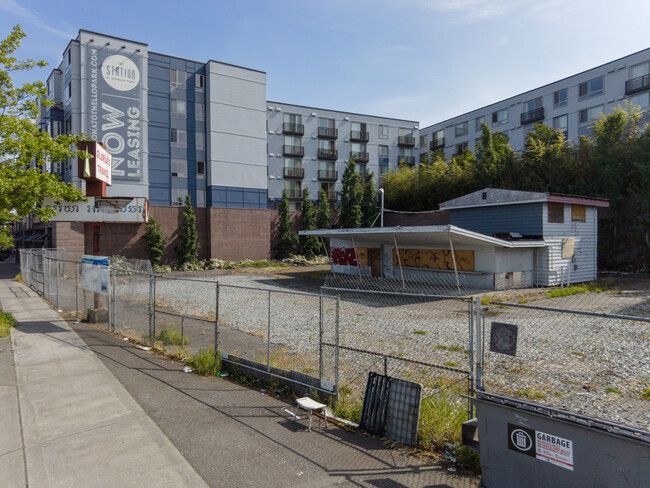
[[267, 101, 419, 210]]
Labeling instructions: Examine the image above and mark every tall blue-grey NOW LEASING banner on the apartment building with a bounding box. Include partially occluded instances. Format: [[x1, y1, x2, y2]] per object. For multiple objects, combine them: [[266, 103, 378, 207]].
[[86, 36, 146, 182]]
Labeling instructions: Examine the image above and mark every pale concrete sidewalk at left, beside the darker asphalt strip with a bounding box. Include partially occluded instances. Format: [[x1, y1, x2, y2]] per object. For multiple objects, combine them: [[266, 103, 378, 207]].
[[0, 262, 206, 488]]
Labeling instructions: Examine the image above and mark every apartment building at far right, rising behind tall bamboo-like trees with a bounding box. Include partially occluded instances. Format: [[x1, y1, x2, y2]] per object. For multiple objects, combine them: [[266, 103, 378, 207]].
[[419, 48, 650, 158]]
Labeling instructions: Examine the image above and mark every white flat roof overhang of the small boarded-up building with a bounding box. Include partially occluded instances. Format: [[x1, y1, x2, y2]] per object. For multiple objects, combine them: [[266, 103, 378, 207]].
[[299, 225, 546, 249]]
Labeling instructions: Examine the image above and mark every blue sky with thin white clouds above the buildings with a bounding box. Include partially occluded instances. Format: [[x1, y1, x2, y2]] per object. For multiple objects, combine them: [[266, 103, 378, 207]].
[[0, 0, 650, 128]]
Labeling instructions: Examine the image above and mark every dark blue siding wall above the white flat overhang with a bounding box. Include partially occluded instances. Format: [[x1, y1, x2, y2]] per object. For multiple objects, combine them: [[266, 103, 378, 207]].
[[449, 203, 543, 236]]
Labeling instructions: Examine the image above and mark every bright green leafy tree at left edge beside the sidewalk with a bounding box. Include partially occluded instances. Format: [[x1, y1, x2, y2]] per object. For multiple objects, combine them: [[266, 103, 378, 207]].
[[0, 25, 85, 247]]
